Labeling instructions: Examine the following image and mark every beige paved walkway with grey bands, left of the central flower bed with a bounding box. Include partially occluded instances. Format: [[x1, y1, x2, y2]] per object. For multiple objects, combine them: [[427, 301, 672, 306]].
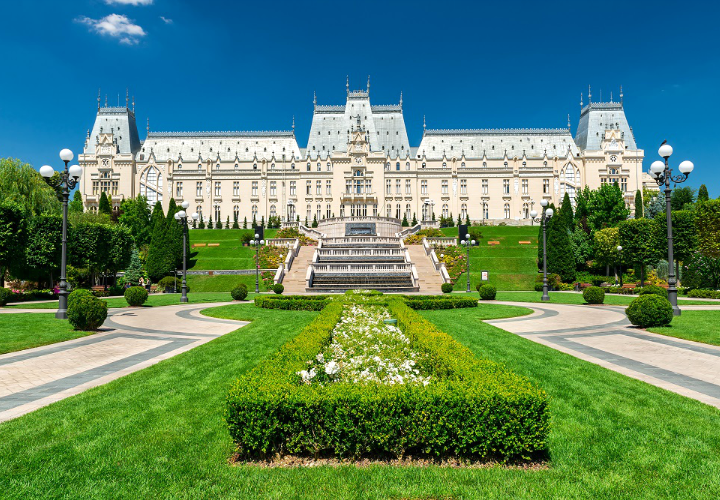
[[0, 303, 247, 422]]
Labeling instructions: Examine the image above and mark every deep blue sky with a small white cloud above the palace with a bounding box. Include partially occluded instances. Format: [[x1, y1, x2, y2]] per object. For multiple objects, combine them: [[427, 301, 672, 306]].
[[0, 0, 720, 197]]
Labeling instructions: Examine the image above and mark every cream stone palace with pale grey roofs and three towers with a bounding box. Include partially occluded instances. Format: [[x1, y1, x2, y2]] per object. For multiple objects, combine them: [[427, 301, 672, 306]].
[[79, 83, 653, 224]]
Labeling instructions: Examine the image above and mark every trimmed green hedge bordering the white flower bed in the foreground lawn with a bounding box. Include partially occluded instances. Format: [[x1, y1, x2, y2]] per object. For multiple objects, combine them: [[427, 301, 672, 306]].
[[225, 299, 549, 460]]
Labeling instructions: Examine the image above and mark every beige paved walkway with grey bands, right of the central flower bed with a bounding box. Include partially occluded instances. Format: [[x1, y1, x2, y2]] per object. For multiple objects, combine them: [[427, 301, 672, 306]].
[[487, 302, 720, 408]]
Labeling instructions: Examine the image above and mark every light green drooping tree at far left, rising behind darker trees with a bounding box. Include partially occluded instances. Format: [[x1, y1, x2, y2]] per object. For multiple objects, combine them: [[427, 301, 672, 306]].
[[0, 158, 60, 215]]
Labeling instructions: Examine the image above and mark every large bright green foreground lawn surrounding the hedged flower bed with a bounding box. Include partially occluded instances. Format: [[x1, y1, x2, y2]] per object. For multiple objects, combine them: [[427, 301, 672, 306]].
[[0, 304, 720, 500]]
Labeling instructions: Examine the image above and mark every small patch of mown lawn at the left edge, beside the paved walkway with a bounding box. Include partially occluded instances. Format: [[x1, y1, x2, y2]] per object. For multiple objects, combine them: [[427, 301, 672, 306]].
[[0, 313, 95, 354]]
